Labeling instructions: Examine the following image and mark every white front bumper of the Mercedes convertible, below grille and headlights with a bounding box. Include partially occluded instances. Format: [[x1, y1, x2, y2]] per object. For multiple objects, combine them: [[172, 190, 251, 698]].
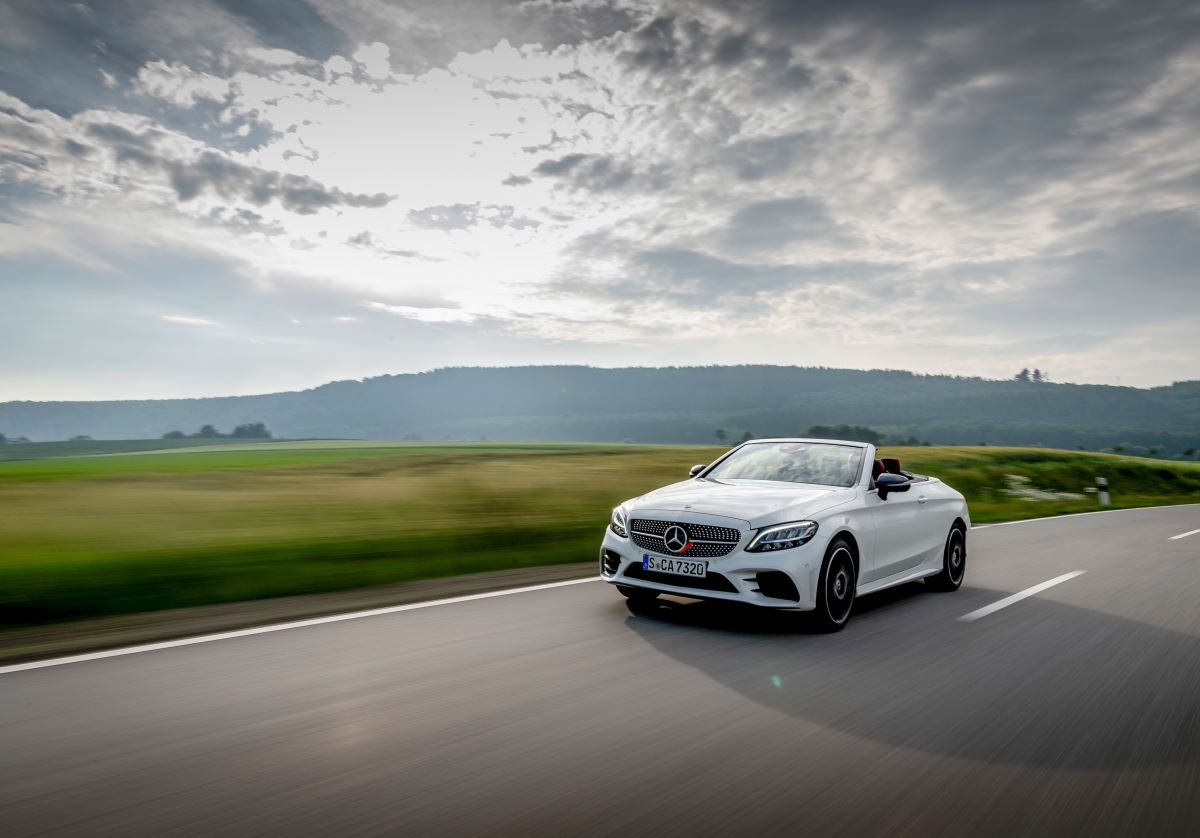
[[600, 528, 826, 611]]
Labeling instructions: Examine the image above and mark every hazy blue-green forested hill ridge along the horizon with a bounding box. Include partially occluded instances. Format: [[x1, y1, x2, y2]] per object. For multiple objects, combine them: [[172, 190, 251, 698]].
[[0, 366, 1200, 451]]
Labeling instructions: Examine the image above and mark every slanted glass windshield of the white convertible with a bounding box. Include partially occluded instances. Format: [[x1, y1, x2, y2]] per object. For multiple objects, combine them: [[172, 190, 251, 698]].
[[704, 442, 863, 487]]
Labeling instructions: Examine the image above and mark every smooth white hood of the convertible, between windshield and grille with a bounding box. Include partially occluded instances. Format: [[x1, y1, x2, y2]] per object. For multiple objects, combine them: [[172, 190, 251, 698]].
[[629, 479, 854, 527]]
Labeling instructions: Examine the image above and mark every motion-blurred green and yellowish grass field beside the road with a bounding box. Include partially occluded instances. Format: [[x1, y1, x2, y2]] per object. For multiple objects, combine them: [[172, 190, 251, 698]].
[[0, 441, 1200, 627]]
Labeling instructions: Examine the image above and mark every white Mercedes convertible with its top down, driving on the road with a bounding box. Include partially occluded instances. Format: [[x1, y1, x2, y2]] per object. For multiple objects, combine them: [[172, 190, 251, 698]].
[[600, 439, 971, 630]]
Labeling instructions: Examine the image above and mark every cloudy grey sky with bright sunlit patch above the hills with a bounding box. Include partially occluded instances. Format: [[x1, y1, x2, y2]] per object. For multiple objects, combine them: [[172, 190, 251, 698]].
[[0, 0, 1200, 401]]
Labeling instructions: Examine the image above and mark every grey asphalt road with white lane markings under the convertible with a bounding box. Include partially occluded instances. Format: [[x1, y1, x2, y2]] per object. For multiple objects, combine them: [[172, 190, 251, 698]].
[[0, 505, 1200, 838]]
